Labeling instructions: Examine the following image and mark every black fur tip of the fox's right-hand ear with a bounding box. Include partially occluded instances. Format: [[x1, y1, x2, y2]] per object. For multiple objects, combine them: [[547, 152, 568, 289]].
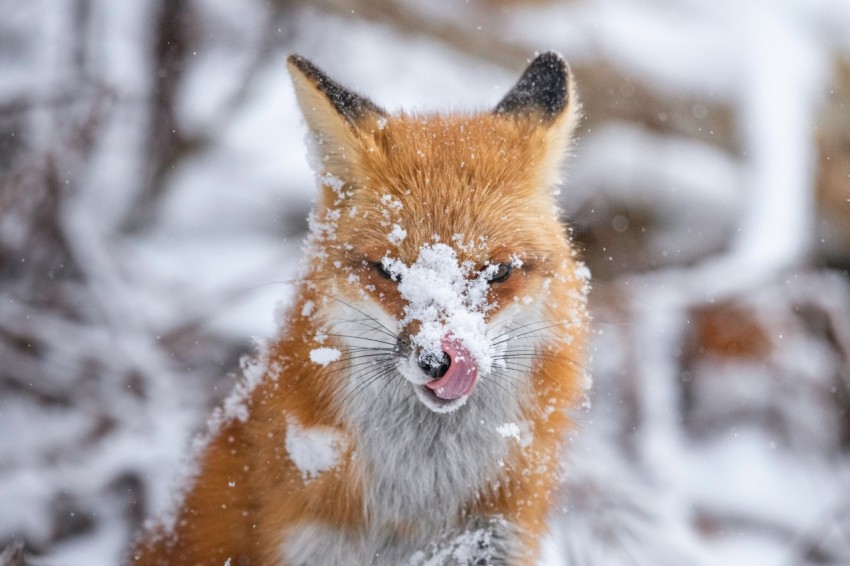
[[496, 51, 570, 118]]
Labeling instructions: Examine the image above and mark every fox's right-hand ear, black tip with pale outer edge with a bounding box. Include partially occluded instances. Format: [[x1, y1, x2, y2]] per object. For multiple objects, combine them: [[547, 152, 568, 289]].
[[493, 51, 580, 193]]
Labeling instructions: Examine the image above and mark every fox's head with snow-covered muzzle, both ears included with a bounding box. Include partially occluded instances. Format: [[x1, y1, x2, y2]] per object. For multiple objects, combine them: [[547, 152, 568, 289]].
[[288, 53, 586, 412]]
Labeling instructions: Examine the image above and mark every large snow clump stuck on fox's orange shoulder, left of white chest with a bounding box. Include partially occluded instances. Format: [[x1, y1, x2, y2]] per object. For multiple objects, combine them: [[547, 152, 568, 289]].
[[286, 417, 345, 481]]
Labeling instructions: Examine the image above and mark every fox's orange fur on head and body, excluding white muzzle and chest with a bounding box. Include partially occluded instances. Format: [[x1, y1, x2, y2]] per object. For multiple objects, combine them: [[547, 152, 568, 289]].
[[131, 53, 587, 565]]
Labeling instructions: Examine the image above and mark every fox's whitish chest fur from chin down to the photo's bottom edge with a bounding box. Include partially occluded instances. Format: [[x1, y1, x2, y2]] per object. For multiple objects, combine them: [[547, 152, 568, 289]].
[[282, 304, 530, 566]]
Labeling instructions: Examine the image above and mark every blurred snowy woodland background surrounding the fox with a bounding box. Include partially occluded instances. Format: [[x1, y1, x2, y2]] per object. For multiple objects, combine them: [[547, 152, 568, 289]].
[[0, 0, 850, 566]]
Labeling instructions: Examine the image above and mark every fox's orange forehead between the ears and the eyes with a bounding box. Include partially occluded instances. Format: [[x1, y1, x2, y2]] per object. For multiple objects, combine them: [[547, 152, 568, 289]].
[[337, 114, 561, 262]]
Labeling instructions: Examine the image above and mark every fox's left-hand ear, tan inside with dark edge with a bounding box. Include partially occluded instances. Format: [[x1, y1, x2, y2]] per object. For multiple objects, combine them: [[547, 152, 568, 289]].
[[286, 54, 387, 178]]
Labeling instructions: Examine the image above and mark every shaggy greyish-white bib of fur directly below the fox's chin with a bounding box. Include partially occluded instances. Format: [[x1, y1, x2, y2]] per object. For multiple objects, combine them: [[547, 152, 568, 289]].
[[328, 304, 531, 529]]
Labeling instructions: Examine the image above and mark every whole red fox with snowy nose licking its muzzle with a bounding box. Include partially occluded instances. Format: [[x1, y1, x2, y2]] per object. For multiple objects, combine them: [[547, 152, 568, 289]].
[[130, 53, 589, 566]]
